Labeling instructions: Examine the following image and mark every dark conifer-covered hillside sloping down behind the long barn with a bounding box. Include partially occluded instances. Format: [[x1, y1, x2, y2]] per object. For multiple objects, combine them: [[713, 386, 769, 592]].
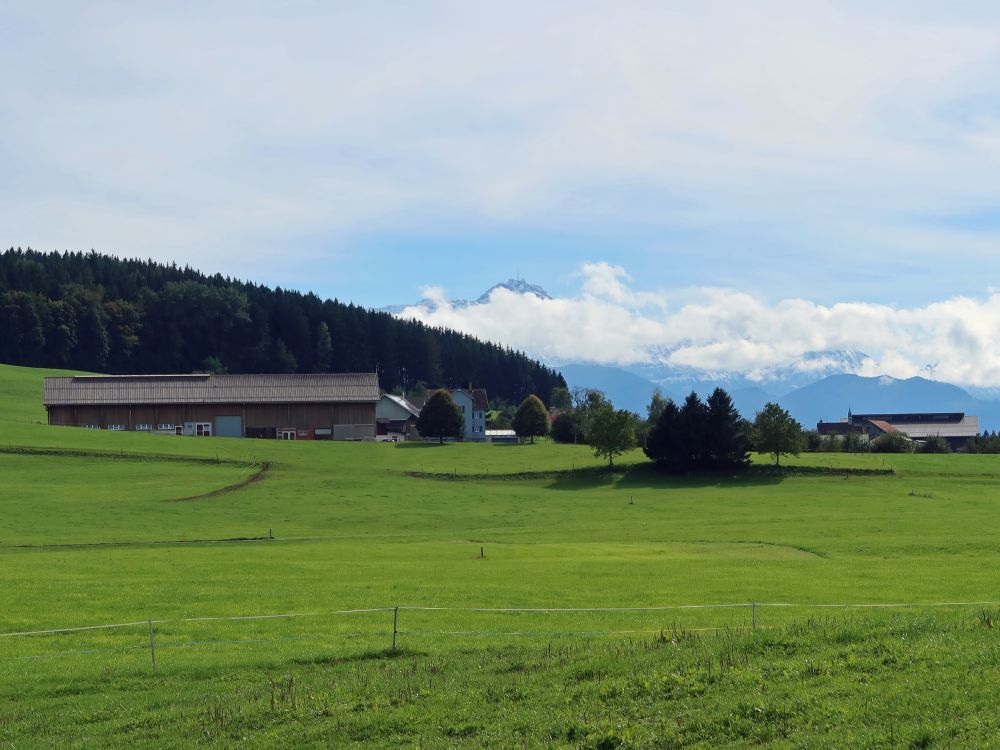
[[0, 249, 565, 401]]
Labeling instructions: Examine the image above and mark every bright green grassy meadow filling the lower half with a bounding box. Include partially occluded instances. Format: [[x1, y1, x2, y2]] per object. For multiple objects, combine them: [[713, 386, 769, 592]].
[[0, 366, 1000, 748]]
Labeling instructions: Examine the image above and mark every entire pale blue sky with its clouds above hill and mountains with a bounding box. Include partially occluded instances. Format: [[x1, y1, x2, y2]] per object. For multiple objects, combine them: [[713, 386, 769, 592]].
[[0, 0, 1000, 385]]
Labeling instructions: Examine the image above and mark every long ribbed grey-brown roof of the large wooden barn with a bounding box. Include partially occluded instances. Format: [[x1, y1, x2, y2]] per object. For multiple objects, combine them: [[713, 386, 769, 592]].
[[44, 372, 381, 406]]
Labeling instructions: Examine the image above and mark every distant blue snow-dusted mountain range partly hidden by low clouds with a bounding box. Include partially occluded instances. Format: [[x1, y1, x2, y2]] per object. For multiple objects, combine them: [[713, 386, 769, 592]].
[[383, 279, 1000, 430]]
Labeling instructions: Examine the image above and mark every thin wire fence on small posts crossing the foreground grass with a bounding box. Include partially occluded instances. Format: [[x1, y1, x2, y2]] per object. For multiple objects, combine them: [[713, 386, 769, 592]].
[[0, 601, 1000, 672]]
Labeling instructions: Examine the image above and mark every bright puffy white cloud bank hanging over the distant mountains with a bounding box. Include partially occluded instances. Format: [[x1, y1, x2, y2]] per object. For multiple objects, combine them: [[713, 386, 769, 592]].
[[402, 263, 1000, 386]]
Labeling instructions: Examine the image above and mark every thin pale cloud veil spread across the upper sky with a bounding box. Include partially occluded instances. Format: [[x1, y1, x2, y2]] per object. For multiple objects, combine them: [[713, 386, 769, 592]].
[[0, 0, 1000, 293]]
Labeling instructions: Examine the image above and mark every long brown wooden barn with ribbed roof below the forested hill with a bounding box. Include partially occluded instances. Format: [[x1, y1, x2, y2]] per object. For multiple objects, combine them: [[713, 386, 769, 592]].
[[44, 373, 381, 440]]
